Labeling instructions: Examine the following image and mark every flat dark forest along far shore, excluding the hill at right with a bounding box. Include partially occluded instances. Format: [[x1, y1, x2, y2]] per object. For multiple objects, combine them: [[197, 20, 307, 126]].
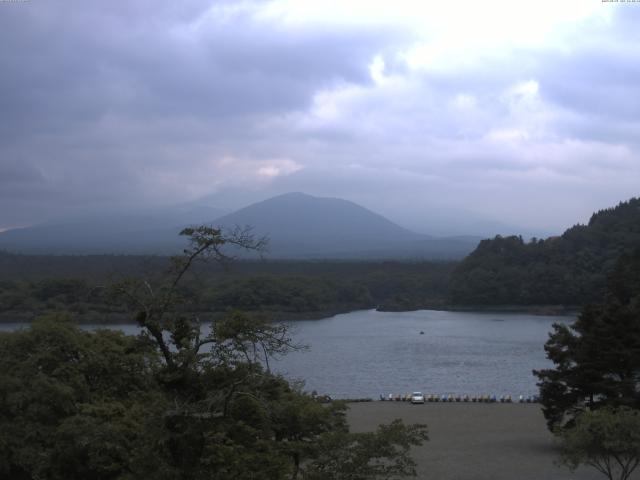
[[0, 254, 455, 323]]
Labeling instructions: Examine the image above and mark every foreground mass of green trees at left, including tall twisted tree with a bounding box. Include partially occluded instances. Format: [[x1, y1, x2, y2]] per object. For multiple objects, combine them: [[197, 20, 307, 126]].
[[0, 227, 427, 480]]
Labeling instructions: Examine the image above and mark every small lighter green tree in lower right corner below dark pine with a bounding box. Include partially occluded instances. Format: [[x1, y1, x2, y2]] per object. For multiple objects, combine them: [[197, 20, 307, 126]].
[[559, 407, 640, 480]]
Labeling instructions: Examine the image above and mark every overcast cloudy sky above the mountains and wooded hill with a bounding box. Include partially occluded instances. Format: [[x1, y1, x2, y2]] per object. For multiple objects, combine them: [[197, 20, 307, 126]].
[[0, 0, 640, 232]]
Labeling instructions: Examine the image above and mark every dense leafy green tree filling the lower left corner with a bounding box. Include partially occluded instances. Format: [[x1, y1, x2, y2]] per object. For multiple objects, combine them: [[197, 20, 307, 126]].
[[0, 314, 168, 480]]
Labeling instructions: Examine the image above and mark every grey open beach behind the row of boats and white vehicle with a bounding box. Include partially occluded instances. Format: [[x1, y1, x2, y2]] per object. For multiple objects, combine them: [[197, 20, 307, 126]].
[[348, 402, 640, 480]]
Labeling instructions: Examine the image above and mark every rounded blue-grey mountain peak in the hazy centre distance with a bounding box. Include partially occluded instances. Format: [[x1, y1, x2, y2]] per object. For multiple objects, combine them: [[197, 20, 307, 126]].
[[208, 193, 479, 258]]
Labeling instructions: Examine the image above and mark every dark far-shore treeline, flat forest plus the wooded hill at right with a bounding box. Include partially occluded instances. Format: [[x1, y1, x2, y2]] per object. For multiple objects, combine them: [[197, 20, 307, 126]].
[[0, 198, 640, 322]]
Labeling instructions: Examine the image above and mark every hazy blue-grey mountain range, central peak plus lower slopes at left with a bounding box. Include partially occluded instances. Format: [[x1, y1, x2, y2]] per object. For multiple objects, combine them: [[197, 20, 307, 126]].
[[0, 193, 479, 259]]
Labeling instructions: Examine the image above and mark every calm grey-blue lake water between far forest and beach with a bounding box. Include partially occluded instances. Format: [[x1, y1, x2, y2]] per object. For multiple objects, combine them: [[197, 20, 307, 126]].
[[0, 310, 573, 398]]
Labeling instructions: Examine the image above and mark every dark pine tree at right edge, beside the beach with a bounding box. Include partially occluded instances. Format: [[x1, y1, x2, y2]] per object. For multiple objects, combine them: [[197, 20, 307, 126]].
[[534, 250, 640, 430]]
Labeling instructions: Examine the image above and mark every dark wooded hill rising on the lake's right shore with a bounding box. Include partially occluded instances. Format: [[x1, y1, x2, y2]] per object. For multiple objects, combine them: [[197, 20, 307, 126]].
[[450, 198, 640, 305]]
